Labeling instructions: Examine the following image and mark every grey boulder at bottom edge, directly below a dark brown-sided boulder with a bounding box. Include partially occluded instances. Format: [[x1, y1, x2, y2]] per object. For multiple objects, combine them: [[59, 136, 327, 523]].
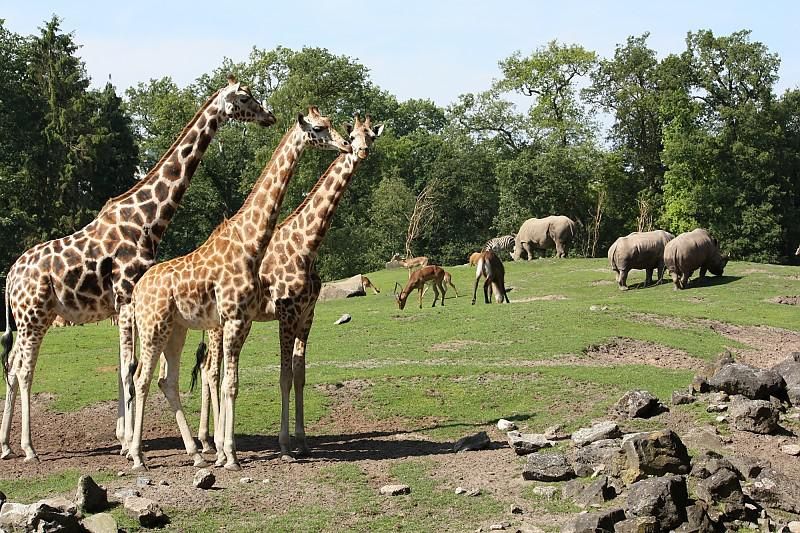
[[625, 475, 689, 529]]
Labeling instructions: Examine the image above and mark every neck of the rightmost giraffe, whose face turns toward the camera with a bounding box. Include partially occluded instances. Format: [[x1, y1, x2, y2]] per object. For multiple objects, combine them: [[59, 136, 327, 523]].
[[281, 153, 360, 255]]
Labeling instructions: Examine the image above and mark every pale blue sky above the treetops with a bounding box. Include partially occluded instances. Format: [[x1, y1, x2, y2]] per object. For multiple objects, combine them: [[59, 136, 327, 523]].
[[0, 0, 800, 106]]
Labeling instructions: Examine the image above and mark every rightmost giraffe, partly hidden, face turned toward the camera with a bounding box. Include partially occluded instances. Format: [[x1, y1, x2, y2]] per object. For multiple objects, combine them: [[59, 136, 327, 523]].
[[195, 115, 383, 462]]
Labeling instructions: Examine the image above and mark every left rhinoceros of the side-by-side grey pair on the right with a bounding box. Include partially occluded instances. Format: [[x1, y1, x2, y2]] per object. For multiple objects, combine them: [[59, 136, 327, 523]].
[[608, 230, 675, 291]]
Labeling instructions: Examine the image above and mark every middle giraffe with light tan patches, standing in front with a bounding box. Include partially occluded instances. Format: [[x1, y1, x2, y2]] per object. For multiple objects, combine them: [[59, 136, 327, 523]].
[[130, 107, 350, 470]]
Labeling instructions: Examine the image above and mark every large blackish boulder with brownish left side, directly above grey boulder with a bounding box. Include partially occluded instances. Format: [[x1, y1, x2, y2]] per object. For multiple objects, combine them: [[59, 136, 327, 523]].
[[622, 429, 689, 482]]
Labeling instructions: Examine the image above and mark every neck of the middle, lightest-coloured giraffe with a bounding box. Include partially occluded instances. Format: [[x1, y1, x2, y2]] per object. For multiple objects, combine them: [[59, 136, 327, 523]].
[[228, 125, 306, 265]]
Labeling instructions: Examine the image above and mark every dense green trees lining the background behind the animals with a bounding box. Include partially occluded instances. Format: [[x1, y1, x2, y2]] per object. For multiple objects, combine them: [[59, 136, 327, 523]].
[[0, 17, 800, 290]]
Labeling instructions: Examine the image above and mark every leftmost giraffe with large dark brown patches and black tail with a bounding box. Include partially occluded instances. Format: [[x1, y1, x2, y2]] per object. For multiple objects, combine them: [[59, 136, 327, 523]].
[[0, 77, 275, 461]]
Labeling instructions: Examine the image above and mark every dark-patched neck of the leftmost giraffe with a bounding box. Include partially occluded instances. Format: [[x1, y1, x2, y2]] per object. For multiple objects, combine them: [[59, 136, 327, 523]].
[[97, 91, 227, 245]]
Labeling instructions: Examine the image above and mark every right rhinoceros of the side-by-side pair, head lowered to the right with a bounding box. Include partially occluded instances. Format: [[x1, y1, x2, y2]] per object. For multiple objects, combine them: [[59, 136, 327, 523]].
[[664, 228, 728, 290]]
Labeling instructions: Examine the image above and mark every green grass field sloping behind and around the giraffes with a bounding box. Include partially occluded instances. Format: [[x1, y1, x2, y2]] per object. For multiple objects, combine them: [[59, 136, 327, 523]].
[[0, 259, 800, 531]]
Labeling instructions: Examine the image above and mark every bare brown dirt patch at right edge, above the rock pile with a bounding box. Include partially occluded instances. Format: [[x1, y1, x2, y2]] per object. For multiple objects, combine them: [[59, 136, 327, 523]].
[[698, 320, 800, 368]]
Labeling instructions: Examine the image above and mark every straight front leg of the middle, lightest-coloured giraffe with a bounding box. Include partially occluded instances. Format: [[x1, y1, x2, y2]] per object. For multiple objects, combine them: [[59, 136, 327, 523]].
[[222, 320, 251, 470]]
